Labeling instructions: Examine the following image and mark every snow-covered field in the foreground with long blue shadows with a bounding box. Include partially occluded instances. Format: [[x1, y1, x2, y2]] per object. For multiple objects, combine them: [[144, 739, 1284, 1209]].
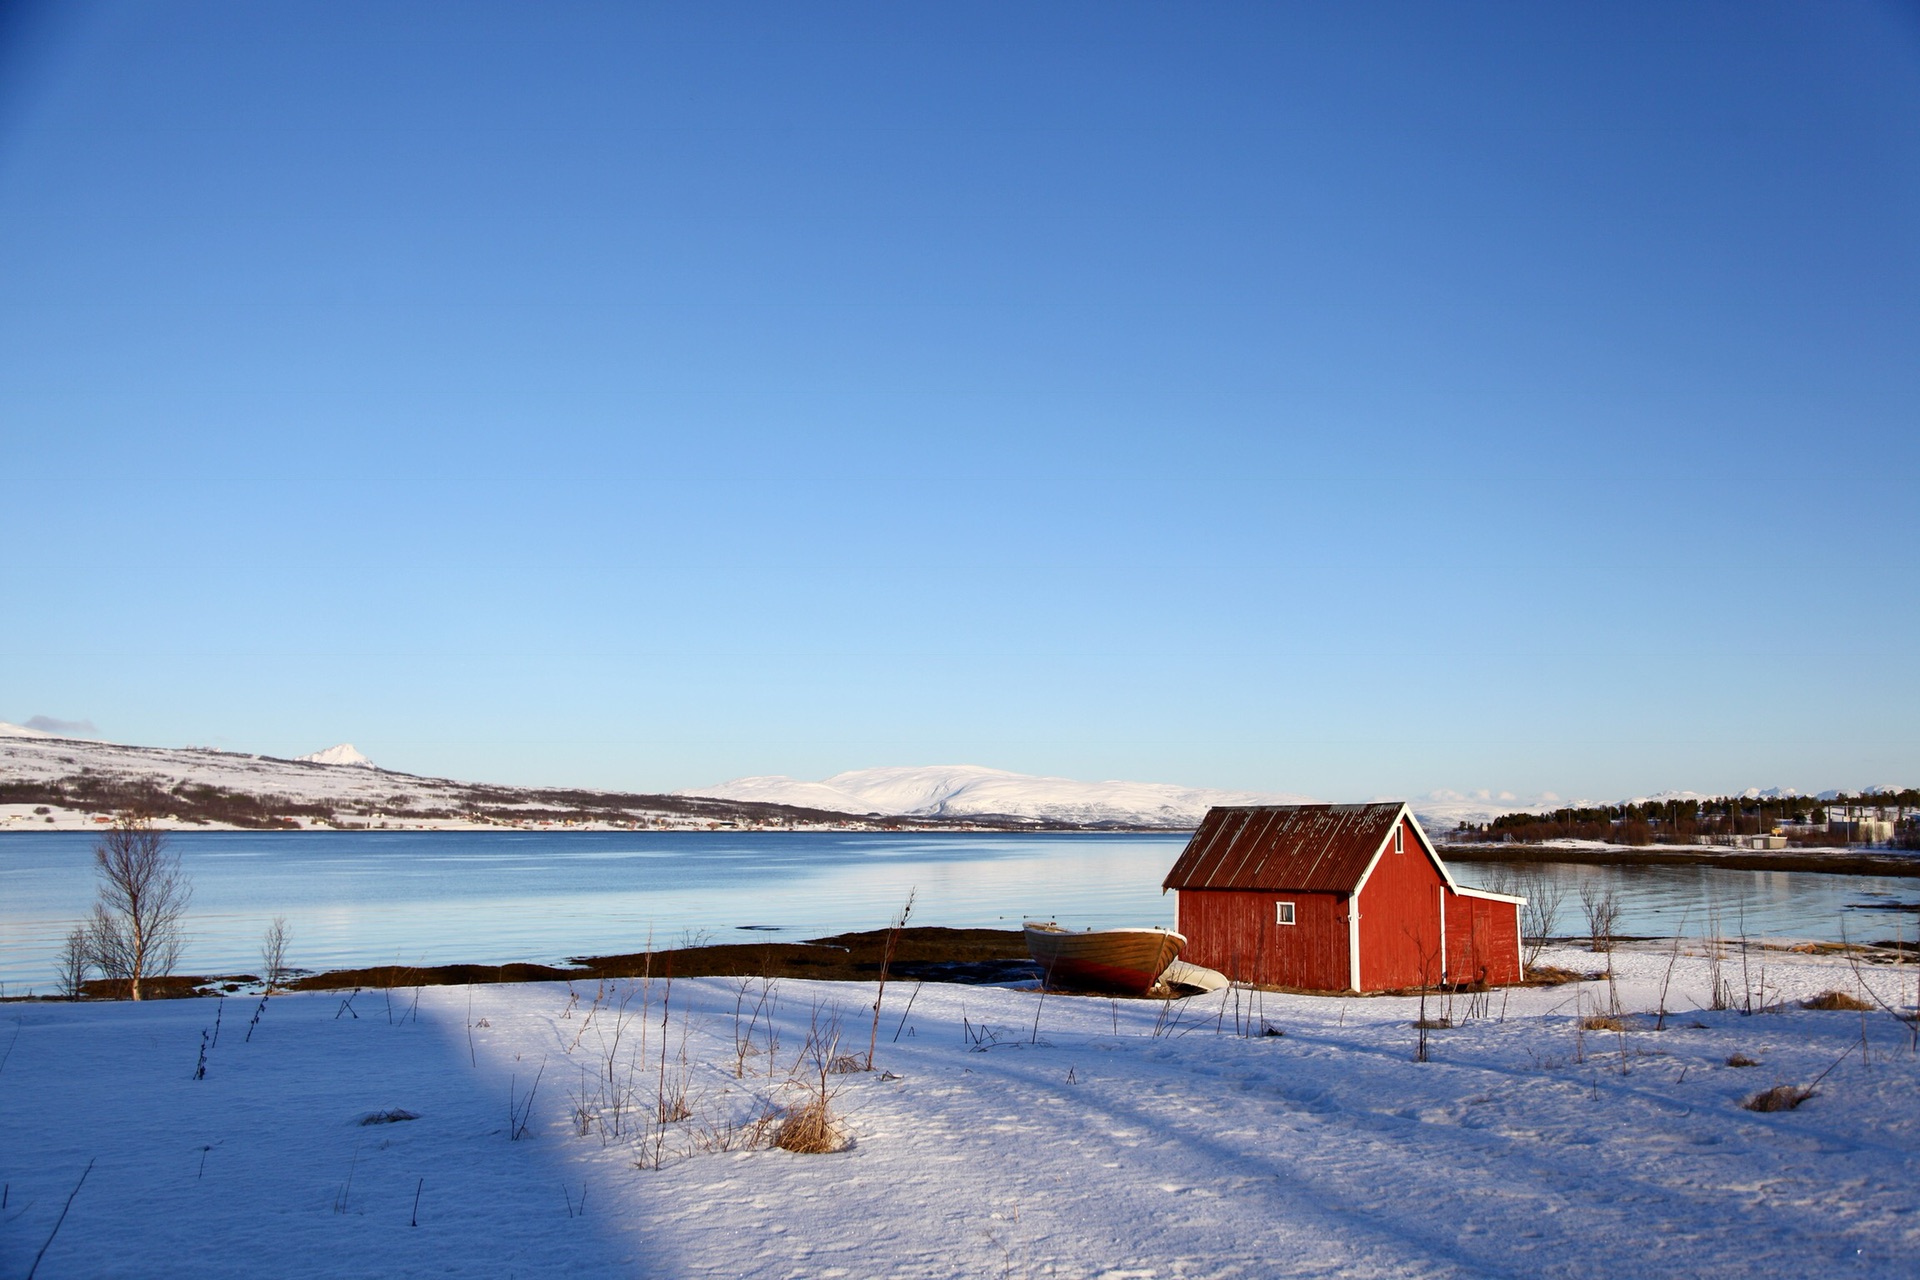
[[0, 948, 1920, 1280]]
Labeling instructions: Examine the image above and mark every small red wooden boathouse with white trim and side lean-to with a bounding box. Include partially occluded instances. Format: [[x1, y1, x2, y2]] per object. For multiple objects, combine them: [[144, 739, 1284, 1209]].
[[1162, 802, 1524, 990]]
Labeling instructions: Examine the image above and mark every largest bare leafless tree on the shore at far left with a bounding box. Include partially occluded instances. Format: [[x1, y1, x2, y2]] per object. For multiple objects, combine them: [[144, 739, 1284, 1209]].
[[86, 816, 194, 1000]]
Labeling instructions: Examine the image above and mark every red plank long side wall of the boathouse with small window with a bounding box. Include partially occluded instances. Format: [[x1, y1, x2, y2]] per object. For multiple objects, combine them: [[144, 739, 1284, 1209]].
[[1179, 889, 1350, 990]]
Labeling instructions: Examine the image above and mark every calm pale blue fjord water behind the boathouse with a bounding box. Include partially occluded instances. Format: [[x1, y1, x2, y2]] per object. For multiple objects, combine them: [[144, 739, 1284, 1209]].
[[0, 831, 1920, 994]]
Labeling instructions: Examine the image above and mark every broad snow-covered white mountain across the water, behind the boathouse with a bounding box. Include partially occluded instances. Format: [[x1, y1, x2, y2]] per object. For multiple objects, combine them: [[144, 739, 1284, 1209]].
[[682, 764, 1304, 829]]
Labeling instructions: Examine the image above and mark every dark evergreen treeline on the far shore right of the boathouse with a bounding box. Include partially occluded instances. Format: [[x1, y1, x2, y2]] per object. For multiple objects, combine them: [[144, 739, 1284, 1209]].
[[1453, 787, 1920, 844]]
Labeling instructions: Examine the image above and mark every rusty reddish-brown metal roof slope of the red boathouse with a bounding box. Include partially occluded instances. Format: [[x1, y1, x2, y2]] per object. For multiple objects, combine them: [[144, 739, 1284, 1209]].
[[1162, 800, 1404, 892]]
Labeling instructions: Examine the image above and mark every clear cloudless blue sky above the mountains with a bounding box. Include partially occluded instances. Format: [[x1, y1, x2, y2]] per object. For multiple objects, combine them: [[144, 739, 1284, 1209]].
[[0, 4, 1920, 798]]
